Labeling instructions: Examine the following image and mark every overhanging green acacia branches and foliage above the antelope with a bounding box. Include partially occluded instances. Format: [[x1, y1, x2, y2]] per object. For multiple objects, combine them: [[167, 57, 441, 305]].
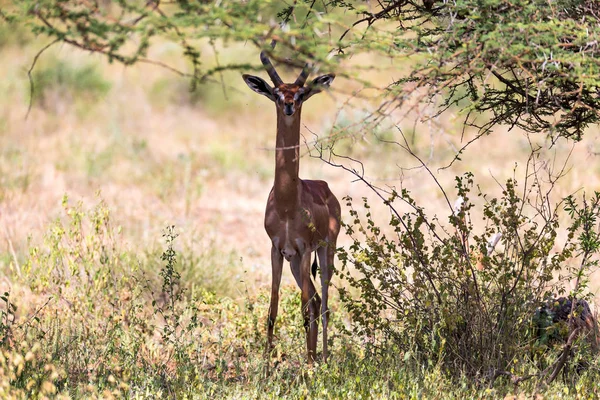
[[1, 0, 600, 140]]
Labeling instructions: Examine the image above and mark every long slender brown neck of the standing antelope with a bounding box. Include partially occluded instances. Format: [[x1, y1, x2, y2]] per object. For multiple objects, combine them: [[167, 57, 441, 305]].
[[273, 109, 301, 215]]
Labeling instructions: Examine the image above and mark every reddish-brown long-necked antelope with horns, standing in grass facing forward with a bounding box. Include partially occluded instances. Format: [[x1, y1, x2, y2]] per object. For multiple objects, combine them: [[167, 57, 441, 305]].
[[243, 46, 340, 364]]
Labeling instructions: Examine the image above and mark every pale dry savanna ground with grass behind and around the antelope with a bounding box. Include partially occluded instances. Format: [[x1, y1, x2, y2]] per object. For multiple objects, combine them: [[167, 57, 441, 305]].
[[0, 18, 600, 398]]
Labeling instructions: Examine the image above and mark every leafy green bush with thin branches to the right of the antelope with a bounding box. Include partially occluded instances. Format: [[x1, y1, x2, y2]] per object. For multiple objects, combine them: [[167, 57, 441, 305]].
[[338, 163, 600, 385]]
